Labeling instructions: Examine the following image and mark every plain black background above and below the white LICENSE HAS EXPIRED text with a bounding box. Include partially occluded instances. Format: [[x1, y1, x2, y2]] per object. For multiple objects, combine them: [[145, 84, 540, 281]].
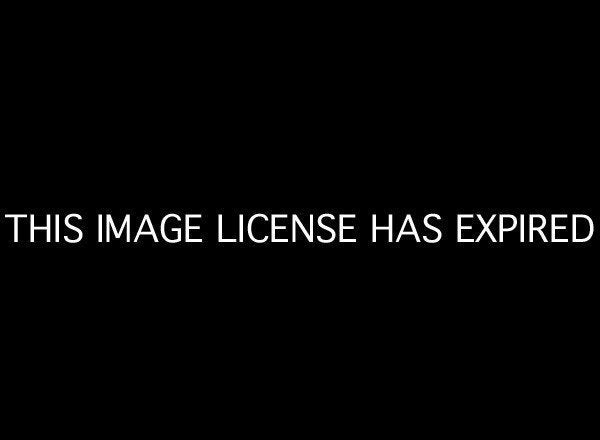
[[1, 5, 598, 433]]
